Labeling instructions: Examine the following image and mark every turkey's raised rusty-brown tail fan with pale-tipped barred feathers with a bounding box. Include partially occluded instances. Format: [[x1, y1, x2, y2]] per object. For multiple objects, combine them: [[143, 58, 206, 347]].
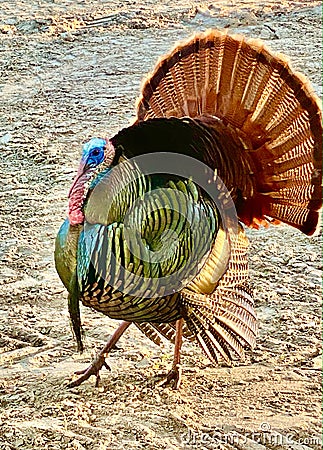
[[137, 30, 322, 235]]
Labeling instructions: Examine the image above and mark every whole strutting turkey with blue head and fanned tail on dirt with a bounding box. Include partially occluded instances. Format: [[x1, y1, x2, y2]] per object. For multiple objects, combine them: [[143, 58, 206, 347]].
[[55, 30, 322, 388]]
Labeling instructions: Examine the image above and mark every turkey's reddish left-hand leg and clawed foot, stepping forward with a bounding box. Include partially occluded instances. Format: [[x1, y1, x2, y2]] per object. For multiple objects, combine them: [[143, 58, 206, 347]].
[[67, 321, 131, 388]]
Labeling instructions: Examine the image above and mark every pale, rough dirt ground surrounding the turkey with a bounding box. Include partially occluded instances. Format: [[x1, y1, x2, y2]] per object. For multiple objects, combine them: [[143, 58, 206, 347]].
[[0, 0, 322, 450]]
